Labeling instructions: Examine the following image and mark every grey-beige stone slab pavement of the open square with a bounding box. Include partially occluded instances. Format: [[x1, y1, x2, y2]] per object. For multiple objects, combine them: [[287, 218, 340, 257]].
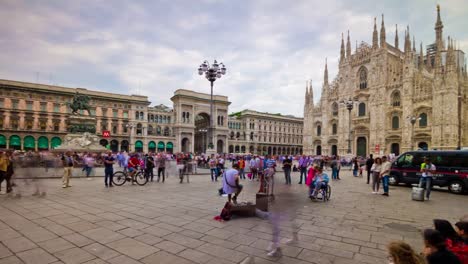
[[0, 171, 468, 264]]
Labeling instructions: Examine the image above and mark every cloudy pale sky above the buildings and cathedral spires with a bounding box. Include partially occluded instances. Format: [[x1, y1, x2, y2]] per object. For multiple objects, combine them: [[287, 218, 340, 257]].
[[0, 0, 468, 116]]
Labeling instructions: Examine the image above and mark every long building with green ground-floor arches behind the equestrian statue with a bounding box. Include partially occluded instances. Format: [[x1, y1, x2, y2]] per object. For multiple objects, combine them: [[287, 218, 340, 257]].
[[0, 80, 176, 152]]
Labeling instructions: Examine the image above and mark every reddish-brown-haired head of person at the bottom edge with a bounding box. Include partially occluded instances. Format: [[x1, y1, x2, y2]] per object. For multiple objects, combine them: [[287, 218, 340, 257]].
[[387, 241, 426, 264]]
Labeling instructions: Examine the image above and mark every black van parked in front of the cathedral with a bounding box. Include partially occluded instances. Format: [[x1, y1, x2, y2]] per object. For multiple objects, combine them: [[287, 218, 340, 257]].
[[389, 150, 468, 194]]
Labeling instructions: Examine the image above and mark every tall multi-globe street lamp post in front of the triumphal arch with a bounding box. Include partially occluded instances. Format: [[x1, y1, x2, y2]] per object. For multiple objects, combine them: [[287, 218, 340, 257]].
[[198, 60, 226, 153]]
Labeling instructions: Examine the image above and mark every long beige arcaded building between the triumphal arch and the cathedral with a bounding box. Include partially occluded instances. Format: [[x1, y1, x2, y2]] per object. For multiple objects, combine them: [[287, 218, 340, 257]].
[[228, 110, 303, 155]]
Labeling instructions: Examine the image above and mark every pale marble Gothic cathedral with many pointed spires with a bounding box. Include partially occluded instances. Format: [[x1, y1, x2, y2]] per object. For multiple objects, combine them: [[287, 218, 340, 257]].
[[303, 6, 468, 157]]
